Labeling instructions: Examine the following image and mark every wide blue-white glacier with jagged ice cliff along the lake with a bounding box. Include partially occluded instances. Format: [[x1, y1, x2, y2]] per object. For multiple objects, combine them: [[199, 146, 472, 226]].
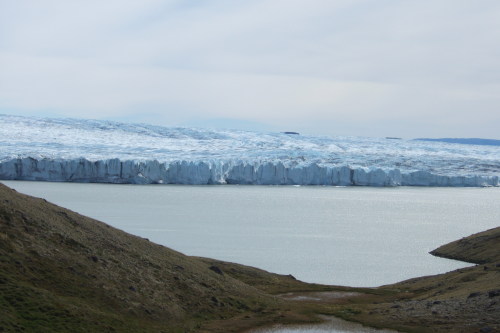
[[0, 115, 500, 186]]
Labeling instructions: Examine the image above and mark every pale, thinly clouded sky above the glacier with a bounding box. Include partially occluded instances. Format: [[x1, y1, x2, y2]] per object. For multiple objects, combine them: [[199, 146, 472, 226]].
[[0, 0, 500, 139]]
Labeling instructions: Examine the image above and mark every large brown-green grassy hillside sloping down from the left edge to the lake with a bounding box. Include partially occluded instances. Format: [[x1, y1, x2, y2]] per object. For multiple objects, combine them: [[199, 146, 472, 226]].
[[0, 184, 328, 332]]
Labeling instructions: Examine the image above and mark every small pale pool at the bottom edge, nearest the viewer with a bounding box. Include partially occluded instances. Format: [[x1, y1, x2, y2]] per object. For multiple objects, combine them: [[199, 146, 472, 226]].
[[248, 316, 396, 333]]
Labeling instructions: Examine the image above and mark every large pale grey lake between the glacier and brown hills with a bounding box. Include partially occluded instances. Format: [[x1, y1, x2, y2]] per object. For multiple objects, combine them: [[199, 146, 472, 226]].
[[4, 181, 500, 286]]
